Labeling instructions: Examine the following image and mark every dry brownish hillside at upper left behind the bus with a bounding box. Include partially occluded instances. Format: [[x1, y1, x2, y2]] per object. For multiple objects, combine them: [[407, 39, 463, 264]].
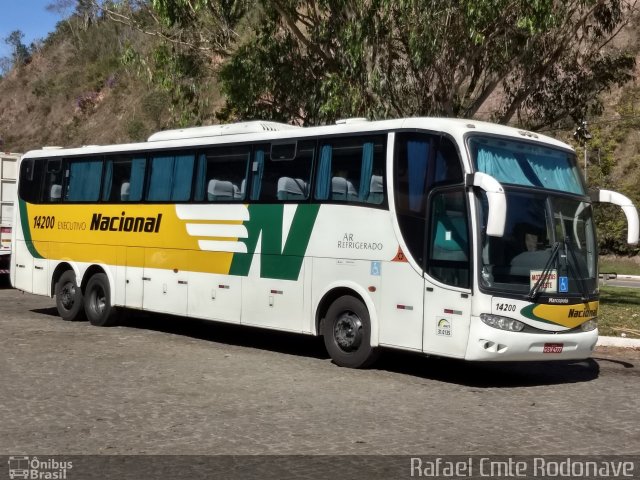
[[0, 11, 206, 152]]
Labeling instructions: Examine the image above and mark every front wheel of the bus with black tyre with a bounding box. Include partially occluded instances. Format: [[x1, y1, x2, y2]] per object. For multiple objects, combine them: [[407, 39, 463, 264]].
[[322, 295, 378, 368]]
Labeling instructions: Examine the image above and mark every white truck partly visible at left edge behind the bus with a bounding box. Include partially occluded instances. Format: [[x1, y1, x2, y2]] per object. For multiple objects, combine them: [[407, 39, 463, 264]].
[[0, 152, 21, 275]]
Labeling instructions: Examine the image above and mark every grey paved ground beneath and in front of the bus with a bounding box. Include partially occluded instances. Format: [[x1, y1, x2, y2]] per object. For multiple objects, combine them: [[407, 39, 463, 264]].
[[0, 286, 640, 455]]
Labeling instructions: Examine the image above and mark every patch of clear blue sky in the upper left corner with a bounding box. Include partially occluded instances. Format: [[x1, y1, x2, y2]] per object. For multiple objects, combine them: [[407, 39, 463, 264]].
[[0, 0, 71, 57]]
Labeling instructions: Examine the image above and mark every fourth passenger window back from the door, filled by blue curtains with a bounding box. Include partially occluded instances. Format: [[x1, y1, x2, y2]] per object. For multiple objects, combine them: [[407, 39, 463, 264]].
[[147, 153, 195, 202]]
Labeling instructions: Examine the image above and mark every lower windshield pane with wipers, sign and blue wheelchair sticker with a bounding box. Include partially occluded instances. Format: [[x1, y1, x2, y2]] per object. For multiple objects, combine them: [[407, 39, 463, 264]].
[[479, 191, 597, 297]]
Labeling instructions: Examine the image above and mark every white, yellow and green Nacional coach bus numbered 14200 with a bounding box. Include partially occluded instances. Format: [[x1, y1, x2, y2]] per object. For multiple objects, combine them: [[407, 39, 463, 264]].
[[11, 118, 638, 367]]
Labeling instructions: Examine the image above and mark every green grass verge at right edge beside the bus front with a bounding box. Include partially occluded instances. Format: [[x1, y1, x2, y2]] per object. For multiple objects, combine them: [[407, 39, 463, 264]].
[[598, 285, 640, 338]]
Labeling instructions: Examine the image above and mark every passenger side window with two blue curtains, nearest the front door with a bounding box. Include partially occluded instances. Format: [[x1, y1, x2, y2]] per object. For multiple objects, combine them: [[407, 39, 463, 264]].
[[315, 137, 385, 204]]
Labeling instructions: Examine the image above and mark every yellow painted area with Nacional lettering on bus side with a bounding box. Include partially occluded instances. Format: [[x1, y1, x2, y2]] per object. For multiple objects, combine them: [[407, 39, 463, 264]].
[[27, 205, 242, 274]]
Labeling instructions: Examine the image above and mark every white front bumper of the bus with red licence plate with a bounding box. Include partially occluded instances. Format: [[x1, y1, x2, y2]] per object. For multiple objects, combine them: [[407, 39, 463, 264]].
[[465, 317, 598, 361]]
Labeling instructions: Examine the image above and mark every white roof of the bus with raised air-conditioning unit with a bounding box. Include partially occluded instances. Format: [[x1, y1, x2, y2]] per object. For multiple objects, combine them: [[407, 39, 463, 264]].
[[25, 117, 572, 158]]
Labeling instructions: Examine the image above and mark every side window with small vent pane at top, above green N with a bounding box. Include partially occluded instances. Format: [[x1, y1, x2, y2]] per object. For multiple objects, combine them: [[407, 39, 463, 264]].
[[251, 141, 316, 202]]
